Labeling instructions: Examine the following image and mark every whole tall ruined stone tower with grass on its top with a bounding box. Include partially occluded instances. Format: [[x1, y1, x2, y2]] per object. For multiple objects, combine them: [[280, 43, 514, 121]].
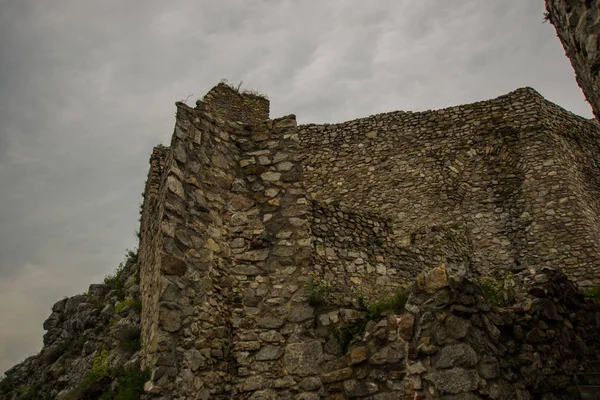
[[140, 84, 320, 399]]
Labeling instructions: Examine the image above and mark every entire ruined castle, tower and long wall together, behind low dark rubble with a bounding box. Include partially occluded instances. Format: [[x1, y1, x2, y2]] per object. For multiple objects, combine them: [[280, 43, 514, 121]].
[[139, 84, 600, 400]]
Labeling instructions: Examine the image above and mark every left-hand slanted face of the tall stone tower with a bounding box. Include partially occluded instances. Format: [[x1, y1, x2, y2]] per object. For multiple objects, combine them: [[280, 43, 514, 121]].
[[140, 100, 245, 398]]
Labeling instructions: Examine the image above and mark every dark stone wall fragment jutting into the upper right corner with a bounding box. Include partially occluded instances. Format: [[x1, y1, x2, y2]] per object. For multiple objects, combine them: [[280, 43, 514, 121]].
[[546, 0, 600, 119]]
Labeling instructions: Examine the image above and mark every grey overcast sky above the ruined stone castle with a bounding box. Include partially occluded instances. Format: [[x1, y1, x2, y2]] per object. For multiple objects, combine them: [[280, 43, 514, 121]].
[[0, 0, 592, 371]]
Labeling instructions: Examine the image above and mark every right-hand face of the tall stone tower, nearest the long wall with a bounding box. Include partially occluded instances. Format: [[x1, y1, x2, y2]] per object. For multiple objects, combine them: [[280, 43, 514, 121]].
[[230, 111, 323, 399]]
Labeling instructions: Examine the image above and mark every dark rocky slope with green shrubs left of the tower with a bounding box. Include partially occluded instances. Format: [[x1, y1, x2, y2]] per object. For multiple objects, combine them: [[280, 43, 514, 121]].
[[0, 252, 147, 400]]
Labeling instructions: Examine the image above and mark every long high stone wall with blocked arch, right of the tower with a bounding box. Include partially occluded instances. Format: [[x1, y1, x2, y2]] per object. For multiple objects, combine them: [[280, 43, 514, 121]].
[[299, 88, 600, 284]]
